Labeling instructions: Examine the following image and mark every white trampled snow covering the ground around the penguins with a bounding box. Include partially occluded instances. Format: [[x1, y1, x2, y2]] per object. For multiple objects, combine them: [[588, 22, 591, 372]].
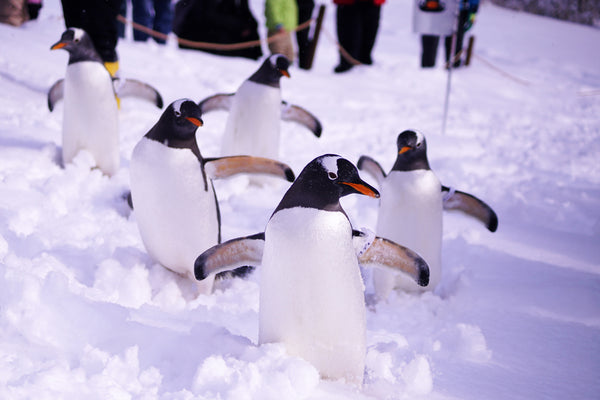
[[0, 0, 600, 399]]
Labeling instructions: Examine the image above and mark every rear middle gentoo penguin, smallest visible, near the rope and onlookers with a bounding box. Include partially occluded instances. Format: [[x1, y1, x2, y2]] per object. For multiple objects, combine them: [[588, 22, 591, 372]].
[[200, 54, 322, 159]]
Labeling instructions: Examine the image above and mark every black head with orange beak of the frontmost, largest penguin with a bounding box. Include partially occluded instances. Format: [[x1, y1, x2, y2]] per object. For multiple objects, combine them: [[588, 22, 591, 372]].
[[277, 154, 379, 211]]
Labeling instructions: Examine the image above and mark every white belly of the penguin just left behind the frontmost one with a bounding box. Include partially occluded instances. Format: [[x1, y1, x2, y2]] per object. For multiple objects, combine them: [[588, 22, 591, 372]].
[[130, 138, 219, 279]]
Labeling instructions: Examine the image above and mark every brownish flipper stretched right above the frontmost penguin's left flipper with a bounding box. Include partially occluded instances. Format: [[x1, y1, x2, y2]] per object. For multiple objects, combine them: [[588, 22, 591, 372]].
[[204, 156, 295, 182]]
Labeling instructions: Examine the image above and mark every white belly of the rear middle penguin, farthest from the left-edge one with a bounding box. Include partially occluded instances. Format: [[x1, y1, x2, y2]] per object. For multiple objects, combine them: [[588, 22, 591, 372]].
[[222, 81, 281, 159]]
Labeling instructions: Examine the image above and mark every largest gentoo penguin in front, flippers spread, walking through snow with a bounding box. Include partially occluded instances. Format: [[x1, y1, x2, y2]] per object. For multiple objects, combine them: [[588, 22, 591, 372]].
[[195, 154, 429, 385]]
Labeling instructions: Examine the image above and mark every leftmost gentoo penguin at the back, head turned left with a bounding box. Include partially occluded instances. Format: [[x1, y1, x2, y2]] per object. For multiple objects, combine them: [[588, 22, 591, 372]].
[[48, 28, 162, 176]]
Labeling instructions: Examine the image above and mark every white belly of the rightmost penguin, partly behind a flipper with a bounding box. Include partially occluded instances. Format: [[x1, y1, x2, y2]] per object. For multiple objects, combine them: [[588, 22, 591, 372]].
[[373, 170, 443, 296]]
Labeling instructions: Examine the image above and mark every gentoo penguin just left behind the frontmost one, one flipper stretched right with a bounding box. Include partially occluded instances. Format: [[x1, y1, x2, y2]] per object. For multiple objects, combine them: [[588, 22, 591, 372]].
[[130, 99, 294, 293]]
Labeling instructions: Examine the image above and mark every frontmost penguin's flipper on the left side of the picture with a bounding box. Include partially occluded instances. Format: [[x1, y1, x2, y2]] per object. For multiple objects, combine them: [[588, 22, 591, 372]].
[[194, 232, 265, 281]]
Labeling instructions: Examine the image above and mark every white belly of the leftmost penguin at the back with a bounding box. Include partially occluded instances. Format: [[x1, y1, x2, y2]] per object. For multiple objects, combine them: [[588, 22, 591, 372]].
[[62, 61, 119, 175]]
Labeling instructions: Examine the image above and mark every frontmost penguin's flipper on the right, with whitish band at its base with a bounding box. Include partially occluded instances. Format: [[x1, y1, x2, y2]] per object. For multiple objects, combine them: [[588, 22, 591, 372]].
[[352, 230, 429, 287]]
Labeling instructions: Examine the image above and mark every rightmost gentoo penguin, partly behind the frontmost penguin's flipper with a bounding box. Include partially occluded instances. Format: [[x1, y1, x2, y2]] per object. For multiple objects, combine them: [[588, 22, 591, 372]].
[[357, 130, 498, 299]]
